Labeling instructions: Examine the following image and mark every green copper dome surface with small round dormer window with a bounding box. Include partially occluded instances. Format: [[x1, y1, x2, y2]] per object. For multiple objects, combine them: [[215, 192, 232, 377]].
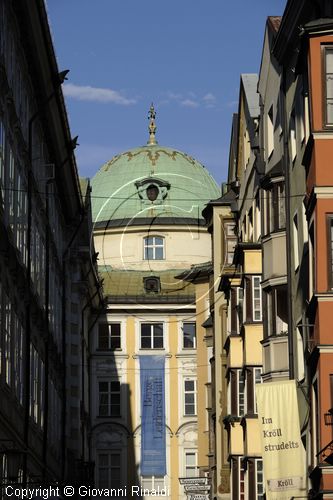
[[91, 143, 220, 225]]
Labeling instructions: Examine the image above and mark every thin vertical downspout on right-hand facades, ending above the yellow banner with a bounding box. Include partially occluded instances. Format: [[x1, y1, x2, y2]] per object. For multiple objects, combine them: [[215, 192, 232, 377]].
[[283, 68, 295, 380]]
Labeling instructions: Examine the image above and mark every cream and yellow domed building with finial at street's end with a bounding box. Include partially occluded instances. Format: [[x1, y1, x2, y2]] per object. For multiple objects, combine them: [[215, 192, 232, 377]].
[[90, 108, 219, 498]]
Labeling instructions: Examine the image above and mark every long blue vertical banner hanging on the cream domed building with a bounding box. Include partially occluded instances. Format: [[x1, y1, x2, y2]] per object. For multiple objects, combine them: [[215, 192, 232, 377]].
[[140, 356, 166, 476]]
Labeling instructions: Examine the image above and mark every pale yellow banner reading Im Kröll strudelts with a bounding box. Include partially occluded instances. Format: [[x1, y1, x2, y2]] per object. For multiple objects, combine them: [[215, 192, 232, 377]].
[[256, 380, 306, 500]]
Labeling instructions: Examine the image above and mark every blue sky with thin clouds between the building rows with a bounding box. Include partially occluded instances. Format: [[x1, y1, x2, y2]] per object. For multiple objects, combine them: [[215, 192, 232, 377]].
[[47, 0, 286, 183]]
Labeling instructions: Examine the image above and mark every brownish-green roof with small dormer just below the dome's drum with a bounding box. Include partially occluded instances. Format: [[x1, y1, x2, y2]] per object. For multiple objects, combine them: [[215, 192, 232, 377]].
[[99, 266, 195, 304]]
